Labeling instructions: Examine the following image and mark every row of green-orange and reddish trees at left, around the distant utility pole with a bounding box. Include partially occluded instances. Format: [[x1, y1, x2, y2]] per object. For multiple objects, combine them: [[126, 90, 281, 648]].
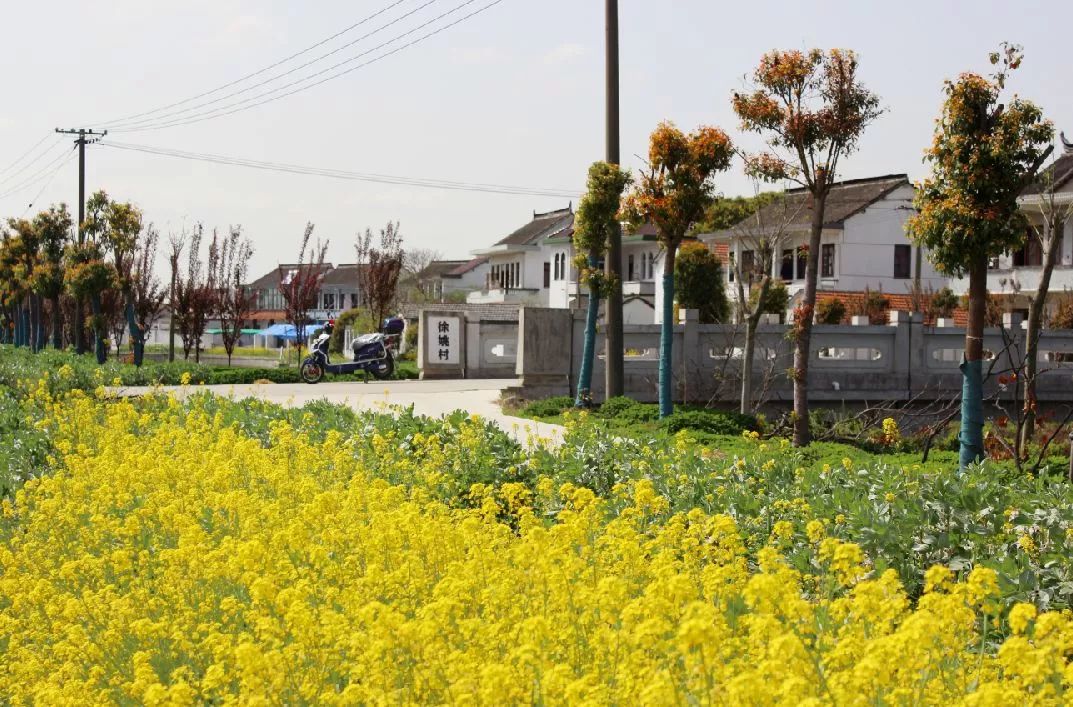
[[0, 191, 253, 366]]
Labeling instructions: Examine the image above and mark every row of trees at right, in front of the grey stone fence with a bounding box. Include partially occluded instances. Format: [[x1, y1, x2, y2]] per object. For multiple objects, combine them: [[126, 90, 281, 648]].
[[575, 44, 1063, 466]]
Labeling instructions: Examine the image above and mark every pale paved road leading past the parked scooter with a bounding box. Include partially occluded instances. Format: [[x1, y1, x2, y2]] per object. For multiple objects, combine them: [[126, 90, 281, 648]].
[[122, 380, 563, 444]]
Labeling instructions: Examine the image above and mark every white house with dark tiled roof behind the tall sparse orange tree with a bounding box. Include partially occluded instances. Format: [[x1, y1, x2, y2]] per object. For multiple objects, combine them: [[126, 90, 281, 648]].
[[686, 174, 947, 323]]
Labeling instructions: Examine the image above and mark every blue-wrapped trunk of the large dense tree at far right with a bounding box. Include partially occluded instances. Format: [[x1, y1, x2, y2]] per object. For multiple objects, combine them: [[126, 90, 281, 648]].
[[958, 254, 987, 471]]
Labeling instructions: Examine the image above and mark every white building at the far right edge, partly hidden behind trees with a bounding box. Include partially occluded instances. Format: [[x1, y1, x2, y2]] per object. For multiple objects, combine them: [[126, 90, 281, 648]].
[[951, 135, 1073, 316]]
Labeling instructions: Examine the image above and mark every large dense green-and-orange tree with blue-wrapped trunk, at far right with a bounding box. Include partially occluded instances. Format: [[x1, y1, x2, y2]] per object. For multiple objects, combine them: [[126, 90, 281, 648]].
[[906, 43, 1054, 471]]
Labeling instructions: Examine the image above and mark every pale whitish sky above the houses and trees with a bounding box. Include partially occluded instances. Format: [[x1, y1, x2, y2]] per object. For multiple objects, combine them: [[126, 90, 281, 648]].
[[0, 0, 1073, 276]]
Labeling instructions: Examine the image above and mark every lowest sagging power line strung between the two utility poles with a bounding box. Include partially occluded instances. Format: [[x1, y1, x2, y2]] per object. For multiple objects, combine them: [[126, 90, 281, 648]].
[[100, 141, 580, 198]]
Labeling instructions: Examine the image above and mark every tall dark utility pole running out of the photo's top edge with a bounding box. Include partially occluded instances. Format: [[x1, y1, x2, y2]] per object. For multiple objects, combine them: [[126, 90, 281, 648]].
[[604, 0, 624, 399]]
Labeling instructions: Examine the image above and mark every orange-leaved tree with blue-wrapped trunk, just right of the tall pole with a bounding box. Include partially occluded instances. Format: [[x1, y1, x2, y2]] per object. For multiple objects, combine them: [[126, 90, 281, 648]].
[[620, 121, 734, 417]]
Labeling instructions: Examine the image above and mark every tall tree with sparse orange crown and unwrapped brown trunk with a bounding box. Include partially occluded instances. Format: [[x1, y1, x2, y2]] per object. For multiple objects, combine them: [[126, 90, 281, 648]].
[[733, 49, 882, 446]]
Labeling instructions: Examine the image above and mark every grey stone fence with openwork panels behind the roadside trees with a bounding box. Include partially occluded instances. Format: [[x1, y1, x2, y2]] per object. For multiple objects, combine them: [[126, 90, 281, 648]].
[[421, 307, 1073, 403]]
